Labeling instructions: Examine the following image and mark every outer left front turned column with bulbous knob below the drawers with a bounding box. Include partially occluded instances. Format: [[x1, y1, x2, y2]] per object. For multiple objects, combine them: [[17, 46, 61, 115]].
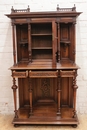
[[12, 78, 18, 118]]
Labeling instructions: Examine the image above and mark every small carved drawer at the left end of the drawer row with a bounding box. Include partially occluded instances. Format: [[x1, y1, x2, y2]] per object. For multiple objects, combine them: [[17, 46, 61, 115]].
[[12, 71, 28, 78]]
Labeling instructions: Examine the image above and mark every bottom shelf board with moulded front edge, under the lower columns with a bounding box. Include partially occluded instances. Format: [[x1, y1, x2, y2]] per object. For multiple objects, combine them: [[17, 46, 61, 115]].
[[13, 104, 78, 125]]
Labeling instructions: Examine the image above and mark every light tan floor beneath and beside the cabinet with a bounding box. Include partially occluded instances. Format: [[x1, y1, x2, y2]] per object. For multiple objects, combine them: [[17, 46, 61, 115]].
[[0, 114, 87, 130]]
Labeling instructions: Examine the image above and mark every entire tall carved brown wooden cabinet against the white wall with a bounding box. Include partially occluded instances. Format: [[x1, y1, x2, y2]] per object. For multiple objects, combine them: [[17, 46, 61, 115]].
[[6, 6, 80, 126]]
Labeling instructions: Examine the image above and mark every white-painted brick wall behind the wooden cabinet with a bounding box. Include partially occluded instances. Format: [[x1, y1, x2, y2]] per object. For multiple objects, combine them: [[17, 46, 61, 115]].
[[0, 0, 87, 113]]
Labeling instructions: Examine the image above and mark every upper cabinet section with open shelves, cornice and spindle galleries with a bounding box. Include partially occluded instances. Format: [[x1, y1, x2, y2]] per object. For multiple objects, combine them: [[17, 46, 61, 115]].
[[6, 6, 81, 67]]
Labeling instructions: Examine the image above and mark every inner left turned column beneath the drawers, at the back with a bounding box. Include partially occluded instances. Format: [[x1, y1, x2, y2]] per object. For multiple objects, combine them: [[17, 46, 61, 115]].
[[29, 78, 33, 115]]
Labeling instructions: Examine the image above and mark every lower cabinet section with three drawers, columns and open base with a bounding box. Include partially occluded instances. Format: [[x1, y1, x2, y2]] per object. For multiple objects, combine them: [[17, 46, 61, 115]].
[[12, 70, 78, 125]]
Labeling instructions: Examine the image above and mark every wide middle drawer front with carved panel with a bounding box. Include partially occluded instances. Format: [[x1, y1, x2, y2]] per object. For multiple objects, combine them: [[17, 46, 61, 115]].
[[29, 71, 58, 78]]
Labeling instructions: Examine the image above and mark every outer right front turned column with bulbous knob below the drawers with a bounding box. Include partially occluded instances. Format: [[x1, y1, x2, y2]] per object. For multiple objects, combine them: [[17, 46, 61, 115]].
[[73, 70, 78, 118]]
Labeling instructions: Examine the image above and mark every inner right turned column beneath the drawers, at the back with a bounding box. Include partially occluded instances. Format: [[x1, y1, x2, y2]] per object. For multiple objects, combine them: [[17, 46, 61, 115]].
[[57, 70, 61, 116]]
